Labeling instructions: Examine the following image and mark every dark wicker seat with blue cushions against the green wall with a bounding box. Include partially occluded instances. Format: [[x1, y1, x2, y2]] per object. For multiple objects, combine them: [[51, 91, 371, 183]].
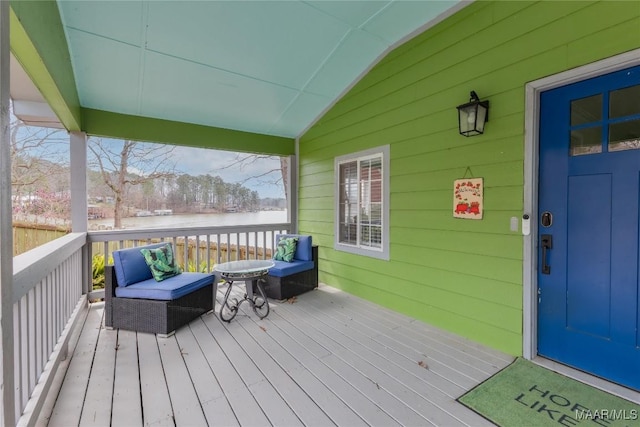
[[264, 234, 318, 300]]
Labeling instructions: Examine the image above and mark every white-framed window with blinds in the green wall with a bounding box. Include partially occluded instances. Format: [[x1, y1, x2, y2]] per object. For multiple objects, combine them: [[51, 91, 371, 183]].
[[334, 145, 389, 260]]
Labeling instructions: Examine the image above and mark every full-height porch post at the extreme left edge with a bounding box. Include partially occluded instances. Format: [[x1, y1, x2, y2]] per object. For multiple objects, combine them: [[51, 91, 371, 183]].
[[0, 1, 16, 426]]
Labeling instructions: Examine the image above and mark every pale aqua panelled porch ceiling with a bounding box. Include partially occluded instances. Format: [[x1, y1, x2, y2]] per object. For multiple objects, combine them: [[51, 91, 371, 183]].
[[12, 0, 461, 137]]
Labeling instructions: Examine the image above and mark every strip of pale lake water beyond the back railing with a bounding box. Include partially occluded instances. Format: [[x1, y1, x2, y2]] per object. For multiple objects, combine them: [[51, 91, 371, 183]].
[[89, 210, 287, 230]]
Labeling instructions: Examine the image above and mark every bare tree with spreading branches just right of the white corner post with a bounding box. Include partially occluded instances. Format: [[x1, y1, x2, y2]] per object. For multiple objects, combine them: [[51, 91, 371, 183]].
[[89, 138, 175, 228]]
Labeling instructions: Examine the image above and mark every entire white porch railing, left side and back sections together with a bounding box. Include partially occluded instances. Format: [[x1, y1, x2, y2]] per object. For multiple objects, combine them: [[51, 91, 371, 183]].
[[13, 223, 291, 426]]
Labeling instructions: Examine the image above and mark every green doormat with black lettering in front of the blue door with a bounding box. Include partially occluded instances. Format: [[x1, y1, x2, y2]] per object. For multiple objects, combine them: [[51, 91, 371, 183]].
[[458, 358, 640, 427]]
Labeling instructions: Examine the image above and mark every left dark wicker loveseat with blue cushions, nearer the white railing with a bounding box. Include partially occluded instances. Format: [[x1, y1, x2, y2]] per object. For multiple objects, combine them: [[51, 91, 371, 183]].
[[105, 243, 218, 335]]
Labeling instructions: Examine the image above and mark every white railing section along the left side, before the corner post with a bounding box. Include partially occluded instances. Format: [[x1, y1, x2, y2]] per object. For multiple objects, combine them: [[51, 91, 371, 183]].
[[12, 233, 87, 425]]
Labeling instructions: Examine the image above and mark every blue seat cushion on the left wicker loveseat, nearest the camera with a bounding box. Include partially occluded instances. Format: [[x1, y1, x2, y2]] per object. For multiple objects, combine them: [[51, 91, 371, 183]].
[[116, 274, 215, 301]]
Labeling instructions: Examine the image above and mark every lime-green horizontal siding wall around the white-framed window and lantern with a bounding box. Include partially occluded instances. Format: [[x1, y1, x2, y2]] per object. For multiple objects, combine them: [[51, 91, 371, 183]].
[[299, 1, 640, 355]]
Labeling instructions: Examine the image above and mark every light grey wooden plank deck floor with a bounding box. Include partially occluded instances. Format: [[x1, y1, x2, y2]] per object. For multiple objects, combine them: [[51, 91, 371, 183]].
[[38, 285, 513, 427]]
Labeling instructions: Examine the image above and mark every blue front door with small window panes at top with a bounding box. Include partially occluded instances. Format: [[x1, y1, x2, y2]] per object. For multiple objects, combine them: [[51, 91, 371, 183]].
[[538, 67, 640, 390]]
